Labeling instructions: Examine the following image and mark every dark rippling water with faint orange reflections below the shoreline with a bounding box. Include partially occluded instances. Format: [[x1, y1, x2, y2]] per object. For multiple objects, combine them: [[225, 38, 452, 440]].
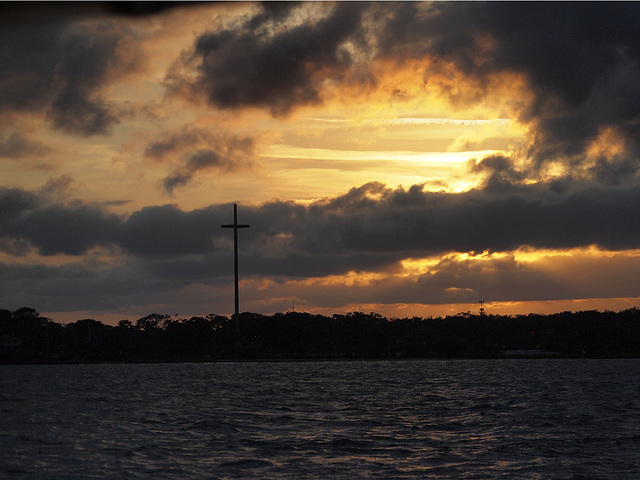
[[0, 360, 640, 480]]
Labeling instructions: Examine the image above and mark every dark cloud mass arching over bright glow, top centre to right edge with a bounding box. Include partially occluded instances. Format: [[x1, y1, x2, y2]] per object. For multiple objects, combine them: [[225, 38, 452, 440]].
[[169, 2, 640, 185]]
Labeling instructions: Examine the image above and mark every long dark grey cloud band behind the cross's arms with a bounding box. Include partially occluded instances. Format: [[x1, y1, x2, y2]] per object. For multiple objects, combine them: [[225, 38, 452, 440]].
[[5, 179, 640, 276]]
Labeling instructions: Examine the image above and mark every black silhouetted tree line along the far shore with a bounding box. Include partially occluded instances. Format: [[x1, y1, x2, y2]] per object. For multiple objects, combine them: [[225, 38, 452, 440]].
[[0, 307, 640, 363]]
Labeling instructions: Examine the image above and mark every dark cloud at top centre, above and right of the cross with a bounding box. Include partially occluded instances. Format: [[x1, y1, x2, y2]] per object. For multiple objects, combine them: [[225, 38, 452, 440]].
[[167, 3, 366, 115]]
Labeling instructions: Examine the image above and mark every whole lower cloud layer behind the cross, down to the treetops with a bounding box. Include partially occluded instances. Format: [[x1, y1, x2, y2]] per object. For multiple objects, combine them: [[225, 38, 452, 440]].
[[0, 178, 640, 316]]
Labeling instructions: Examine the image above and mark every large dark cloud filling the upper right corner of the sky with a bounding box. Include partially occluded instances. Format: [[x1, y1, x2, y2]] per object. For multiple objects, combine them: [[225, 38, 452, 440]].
[[372, 2, 640, 179]]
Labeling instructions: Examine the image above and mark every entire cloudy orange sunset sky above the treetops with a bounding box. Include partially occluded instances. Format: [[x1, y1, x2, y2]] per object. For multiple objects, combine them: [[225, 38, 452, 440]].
[[0, 2, 640, 324]]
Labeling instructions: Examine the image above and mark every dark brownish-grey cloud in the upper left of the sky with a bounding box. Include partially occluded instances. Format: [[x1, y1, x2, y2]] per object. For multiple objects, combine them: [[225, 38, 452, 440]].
[[0, 20, 138, 136]]
